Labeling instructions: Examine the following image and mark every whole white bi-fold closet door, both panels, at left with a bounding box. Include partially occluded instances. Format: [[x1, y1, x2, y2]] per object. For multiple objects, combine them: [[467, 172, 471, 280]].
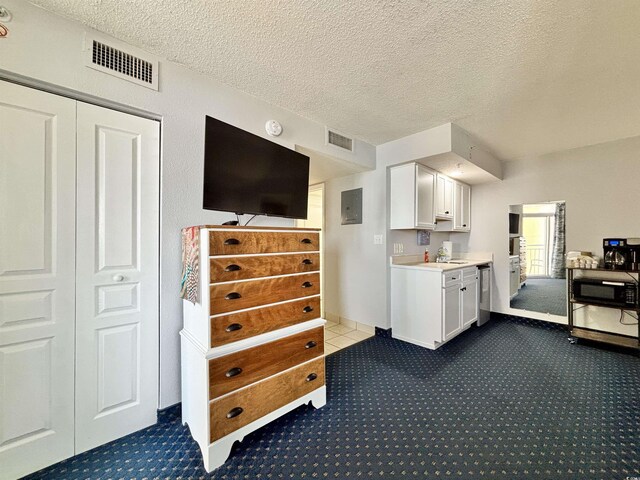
[[0, 82, 159, 478]]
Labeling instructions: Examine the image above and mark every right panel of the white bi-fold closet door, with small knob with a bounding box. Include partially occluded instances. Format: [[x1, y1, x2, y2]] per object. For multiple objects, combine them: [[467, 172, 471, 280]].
[[76, 103, 159, 453]]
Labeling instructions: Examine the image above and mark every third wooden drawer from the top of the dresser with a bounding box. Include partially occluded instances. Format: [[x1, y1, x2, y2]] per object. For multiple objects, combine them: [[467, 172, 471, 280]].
[[209, 273, 320, 315]]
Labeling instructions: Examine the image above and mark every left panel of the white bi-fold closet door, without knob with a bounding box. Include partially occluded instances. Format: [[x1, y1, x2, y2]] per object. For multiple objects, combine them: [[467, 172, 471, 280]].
[[0, 82, 76, 478]]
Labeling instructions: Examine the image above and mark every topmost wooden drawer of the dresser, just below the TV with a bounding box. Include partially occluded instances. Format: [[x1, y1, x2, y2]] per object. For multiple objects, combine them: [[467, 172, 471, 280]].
[[209, 231, 320, 255]]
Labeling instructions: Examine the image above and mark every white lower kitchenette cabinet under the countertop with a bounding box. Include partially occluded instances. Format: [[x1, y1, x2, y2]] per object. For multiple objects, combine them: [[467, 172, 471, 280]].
[[391, 267, 478, 349]]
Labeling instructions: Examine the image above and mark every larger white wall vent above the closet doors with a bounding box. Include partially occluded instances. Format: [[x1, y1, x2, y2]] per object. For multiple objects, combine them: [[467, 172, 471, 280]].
[[85, 36, 158, 90]]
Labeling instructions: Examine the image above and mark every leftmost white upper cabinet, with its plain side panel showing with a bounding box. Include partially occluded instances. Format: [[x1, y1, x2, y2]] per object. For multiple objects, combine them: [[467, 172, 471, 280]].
[[389, 163, 436, 230]]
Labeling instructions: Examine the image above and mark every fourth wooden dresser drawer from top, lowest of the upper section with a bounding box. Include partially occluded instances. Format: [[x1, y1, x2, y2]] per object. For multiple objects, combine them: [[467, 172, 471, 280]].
[[210, 297, 320, 348]]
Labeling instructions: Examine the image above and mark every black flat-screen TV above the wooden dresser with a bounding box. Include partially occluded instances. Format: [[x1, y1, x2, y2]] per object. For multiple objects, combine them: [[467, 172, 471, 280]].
[[203, 116, 309, 218]]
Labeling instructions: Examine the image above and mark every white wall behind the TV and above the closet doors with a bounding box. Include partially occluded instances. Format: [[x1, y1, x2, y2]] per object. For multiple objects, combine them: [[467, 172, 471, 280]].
[[0, 0, 375, 407]]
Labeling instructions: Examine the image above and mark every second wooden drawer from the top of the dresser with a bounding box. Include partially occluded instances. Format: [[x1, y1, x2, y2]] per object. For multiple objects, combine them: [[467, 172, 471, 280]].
[[209, 253, 320, 283]]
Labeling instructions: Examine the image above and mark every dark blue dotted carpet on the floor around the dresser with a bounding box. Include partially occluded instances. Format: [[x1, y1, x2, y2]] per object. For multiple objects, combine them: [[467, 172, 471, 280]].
[[22, 317, 640, 480]]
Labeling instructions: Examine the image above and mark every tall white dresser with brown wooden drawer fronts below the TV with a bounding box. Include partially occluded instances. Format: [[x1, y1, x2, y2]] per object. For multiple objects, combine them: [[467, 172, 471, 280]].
[[180, 226, 326, 472]]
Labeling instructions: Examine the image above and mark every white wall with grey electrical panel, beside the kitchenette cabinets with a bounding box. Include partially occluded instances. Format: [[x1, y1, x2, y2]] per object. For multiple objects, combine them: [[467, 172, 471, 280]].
[[325, 130, 458, 328]]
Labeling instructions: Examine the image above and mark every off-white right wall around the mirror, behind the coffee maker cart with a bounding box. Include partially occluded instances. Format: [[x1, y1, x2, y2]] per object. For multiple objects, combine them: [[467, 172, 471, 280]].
[[462, 137, 640, 323]]
